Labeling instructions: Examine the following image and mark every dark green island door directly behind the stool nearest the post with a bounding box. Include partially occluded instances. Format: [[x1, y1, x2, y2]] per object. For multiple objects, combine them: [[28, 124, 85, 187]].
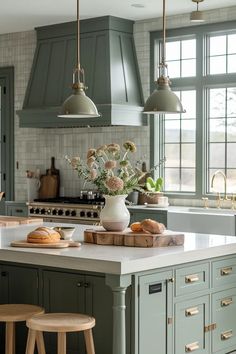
[[43, 271, 85, 354]]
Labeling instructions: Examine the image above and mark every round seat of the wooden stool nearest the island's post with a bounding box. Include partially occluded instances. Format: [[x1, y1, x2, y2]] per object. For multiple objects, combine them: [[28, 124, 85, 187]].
[[26, 313, 95, 332]]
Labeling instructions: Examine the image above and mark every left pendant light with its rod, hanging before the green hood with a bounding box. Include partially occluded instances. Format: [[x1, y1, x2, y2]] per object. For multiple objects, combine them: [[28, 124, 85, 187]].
[[58, 0, 100, 118]]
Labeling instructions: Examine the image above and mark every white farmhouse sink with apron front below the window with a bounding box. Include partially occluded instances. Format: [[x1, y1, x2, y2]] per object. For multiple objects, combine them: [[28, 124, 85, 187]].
[[167, 208, 236, 236]]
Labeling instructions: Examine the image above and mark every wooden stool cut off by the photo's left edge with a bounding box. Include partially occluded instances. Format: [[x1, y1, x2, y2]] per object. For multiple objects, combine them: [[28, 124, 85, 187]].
[[0, 304, 44, 354]]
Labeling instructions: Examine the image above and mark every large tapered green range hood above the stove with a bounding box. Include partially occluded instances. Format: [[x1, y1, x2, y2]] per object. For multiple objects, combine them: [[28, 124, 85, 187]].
[[18, 16, 147, 128]]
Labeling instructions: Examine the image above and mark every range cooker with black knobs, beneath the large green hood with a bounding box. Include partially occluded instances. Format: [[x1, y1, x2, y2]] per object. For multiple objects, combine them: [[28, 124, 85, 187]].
[[28, 191, 104, 225]]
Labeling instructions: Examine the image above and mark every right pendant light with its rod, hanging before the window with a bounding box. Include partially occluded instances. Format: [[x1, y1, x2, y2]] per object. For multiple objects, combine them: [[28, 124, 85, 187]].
[[143, 0, 185, 114]]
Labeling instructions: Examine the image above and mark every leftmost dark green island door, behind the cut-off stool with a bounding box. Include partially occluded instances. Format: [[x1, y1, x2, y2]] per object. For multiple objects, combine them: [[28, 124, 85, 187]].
[[0, 265, 39, 354]]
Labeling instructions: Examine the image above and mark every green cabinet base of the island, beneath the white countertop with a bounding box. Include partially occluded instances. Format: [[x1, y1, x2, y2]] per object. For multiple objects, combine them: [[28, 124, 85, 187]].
[[0, 255, 236, 354]]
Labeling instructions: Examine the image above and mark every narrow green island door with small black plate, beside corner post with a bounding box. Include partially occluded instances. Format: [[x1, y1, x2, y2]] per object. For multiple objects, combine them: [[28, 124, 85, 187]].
[[138, 272, 173, 354]]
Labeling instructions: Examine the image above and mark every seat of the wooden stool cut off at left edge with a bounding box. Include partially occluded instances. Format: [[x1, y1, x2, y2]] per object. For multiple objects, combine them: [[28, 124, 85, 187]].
[[0, 304, 44, 322]]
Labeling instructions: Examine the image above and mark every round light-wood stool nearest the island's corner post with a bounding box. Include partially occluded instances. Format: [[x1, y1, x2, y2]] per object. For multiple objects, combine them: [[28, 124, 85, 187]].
[[26, 313, 95, 354]]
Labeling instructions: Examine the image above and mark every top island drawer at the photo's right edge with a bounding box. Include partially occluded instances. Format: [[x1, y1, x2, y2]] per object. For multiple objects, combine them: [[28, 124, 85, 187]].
[[212, 258, 236, 288]]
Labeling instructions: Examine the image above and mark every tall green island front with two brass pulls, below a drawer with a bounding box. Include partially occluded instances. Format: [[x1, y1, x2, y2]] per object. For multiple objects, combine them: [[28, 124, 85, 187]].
[[174, 295, 211, 354]]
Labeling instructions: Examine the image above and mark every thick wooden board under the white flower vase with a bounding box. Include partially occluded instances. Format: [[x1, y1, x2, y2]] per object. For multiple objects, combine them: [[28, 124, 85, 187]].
[[84, 229, 184, 247]]
